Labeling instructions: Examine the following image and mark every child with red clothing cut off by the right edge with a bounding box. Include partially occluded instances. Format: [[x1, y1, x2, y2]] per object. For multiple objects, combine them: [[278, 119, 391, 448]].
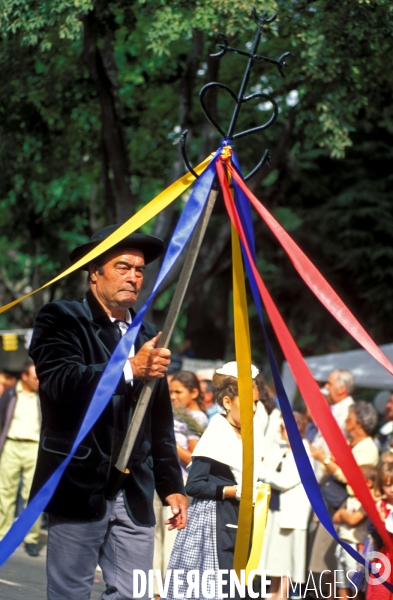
[[366, 462, 393, 600]]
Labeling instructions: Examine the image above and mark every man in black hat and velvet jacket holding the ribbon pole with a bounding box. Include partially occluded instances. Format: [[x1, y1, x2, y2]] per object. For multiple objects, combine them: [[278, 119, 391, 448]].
[[30, 226, 187, 600]]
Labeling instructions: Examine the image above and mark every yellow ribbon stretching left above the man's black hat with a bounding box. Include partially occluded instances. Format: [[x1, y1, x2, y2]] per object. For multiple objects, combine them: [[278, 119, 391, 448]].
[[0, 155, 213, 313]]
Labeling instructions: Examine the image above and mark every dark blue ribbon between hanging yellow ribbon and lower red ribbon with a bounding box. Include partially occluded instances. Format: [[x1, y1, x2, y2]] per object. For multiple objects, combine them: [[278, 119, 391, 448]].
[[226, 168, 393, 592]]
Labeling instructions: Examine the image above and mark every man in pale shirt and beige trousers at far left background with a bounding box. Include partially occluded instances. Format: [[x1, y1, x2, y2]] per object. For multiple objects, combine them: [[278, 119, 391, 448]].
[[0, 359, 41, 556]]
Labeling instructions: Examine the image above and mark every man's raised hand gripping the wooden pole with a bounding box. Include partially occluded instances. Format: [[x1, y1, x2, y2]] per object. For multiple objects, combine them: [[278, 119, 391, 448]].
[[128, 332, 171, 379]]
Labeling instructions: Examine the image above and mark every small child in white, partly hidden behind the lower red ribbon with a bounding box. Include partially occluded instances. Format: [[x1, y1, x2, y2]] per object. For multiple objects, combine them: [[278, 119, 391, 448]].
[[333, 465, 378, 600]]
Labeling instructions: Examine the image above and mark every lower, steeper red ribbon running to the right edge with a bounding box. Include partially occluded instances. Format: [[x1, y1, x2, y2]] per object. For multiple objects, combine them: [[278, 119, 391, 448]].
[[217, 157, 390, 556]]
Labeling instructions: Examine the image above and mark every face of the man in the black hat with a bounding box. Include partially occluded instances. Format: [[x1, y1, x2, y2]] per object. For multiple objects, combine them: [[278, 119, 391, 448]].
[[90, 249, 145, 311]]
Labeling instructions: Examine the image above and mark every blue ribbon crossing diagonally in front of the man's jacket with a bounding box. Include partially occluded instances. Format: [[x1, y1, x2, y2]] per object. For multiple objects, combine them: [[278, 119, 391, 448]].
[[0, 151, 217, 566]]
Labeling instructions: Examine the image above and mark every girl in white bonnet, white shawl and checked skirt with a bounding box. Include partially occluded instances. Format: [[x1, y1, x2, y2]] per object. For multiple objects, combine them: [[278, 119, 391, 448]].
[[167, 362, 260, 600]]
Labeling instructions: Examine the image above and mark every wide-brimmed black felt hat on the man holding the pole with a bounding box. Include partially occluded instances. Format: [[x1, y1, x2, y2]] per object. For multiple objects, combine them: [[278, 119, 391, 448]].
[[70, 225, 165, 271]]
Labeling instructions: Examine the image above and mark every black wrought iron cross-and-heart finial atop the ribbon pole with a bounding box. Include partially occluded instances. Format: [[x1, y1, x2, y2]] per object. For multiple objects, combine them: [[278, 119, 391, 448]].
[[179, 6, 291, 181]]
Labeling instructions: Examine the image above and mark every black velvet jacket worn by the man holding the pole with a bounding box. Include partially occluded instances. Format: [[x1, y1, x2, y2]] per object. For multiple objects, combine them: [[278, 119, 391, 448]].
[[30, 291, 184, 526]]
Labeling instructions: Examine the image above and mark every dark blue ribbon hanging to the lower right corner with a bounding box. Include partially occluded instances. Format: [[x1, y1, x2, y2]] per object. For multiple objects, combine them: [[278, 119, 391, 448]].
[[232, 153, 393, 592]]
